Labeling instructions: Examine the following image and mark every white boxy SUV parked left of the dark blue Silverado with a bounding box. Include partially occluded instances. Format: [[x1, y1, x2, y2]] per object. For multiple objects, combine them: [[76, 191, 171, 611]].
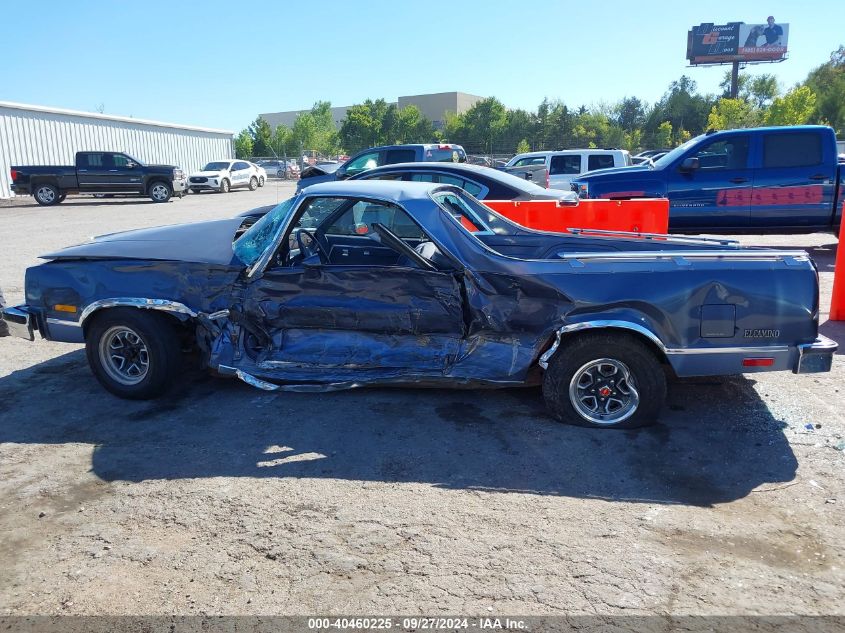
[[504, 149, 633, 189]]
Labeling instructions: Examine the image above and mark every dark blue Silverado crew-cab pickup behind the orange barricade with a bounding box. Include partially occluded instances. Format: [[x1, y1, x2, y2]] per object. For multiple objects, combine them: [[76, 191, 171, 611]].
[[572, 125, 845, 233]]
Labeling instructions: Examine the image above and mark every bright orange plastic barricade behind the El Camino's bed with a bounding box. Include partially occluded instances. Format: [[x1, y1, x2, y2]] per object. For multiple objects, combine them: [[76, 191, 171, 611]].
[[484, 198, 669, 233]]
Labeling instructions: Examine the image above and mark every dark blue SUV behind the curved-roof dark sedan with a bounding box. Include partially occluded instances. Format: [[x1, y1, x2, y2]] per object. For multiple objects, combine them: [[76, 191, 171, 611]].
[[296, 143, 467, 191]]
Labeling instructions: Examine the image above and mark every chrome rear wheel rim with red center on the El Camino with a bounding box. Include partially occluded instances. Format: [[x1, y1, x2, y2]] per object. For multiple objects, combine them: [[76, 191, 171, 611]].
[[569, 358, 640, 425]]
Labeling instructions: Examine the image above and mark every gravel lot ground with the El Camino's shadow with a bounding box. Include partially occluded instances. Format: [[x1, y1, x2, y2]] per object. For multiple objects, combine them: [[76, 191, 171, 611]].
[[0, 181, 845, 616]]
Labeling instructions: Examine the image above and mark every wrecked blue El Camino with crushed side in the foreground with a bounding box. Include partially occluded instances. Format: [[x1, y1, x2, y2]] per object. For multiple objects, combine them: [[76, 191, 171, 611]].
[[2, 180, 837, 428]]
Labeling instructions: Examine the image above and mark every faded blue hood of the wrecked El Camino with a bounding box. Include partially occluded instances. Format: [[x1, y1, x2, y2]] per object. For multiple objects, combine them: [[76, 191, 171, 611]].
[[41, 218, 244, 266]]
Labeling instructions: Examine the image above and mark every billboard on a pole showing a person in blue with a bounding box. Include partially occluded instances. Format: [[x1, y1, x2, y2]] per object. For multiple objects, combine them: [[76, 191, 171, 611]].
[[687, 16, 789, 64]]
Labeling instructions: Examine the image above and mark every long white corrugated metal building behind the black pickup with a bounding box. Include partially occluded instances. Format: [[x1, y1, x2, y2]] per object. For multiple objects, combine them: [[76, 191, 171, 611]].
[[0, 101, 235, 198]]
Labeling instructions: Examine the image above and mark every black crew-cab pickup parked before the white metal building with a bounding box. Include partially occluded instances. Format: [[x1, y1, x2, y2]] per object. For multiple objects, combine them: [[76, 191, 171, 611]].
[[11, 152, 186, 205]]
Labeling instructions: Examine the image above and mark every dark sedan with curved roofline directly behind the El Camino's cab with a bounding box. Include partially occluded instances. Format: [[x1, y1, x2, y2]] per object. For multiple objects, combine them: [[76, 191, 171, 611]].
[[350, 163, 577, 203]]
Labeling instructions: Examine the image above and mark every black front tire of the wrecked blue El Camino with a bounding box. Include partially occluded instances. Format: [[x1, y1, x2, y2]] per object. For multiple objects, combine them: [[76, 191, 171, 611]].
[[85, 308, 182, 400]]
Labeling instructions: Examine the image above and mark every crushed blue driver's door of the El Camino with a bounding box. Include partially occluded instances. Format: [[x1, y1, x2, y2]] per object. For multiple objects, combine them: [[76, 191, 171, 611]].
[[237, 197, 465, 382]]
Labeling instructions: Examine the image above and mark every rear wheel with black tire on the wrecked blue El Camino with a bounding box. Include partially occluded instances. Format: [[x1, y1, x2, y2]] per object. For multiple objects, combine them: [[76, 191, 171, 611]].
[[543, 333, 666, 429]]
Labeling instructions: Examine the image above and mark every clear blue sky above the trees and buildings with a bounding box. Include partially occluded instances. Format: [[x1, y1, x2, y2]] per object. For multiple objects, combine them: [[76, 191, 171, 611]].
[[0, 0, 845, 131]]
